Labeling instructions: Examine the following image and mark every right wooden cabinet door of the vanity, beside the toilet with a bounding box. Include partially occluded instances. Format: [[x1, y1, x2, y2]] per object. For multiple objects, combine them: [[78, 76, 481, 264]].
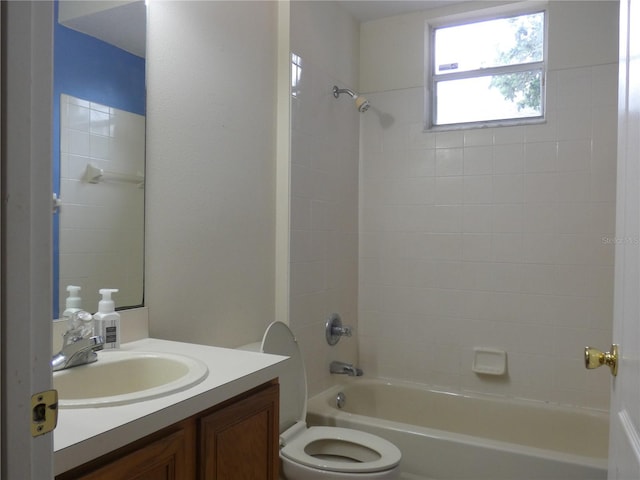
[[199, 383, 279, 480]]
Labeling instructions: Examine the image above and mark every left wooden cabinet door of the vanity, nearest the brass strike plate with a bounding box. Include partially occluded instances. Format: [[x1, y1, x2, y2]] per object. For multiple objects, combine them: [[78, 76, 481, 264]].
[[57, 421, 195, 480]]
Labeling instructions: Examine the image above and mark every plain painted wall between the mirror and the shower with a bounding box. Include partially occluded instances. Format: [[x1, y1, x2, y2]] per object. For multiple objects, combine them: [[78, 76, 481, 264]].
[[145, 1, 277, 346]]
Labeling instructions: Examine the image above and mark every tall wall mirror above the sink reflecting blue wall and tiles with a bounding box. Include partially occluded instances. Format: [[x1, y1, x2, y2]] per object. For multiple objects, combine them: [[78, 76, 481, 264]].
[[52, 0, 146, 319]]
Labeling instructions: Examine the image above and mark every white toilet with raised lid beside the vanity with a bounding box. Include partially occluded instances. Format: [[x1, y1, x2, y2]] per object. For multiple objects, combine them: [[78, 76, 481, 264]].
[[260, 322, 402, 480]]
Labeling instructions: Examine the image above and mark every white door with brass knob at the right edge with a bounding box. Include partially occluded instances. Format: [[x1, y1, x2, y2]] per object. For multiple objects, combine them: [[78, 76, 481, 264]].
[[609, 0, 640, 480]]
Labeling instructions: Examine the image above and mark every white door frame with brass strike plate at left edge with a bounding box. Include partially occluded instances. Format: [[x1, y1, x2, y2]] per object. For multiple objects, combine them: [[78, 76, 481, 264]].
[[0, 1, 53, 480]]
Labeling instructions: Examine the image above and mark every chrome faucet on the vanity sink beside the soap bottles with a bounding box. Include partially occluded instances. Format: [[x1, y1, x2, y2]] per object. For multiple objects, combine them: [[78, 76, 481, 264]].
[[51, 311, 104, 372]]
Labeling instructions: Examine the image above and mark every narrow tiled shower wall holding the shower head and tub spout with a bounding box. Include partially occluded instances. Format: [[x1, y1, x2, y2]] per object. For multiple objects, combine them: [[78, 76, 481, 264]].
[[290, 1, 359, 394]]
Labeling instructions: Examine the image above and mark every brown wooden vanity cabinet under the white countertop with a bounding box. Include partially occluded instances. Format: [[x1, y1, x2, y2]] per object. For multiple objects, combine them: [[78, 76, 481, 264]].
[[56, 380, 279, 480]]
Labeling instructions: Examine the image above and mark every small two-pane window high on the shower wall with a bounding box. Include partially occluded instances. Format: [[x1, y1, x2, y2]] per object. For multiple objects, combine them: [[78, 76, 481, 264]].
[[430, 12, 546, 127]]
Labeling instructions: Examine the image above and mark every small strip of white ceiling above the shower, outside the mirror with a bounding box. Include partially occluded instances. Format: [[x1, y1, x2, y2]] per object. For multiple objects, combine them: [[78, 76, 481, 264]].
[[336, 0, 460, 22]]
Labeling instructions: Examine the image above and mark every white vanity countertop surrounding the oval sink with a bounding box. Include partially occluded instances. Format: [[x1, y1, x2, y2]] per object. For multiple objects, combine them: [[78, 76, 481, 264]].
[[53, 338, 287, 475]]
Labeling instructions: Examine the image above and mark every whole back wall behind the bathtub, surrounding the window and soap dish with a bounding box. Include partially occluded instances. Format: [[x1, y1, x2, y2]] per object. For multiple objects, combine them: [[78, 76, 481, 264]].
[[359, 2, 618, 408]]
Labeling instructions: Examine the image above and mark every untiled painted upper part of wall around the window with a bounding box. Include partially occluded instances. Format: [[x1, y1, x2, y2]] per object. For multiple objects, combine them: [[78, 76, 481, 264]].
[[360, 0, 618, 93]]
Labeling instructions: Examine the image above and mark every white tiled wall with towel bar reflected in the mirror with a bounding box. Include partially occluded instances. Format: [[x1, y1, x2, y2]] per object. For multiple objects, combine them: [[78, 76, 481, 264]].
[[59, 95, 145, 312]]
